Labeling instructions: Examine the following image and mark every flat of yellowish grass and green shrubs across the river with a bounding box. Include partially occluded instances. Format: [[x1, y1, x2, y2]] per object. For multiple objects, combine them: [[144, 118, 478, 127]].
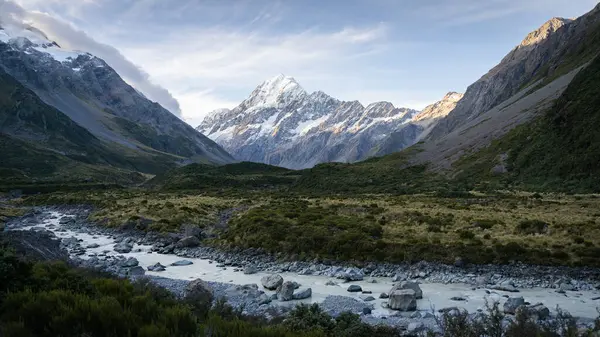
[[21, 190, 600, 267]]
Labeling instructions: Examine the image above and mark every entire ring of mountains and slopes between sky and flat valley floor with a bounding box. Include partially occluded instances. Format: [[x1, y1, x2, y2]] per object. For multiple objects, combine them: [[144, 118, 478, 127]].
[[0, 0, 600, 193]]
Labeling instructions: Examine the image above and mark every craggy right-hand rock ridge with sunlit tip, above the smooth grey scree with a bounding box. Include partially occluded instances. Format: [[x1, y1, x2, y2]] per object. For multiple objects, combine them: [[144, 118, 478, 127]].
[[428, 5, 600, 140]]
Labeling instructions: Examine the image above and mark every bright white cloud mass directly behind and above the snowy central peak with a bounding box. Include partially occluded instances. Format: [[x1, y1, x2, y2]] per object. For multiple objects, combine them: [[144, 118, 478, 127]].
[[119, 24, 387, 123]]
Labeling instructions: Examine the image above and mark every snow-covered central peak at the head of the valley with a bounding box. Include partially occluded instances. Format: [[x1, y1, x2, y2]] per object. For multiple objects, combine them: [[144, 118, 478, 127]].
[[197, 75, 454, 169]]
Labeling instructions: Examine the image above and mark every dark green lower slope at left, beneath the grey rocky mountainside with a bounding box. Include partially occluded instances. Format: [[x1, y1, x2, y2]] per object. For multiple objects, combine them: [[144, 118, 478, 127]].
[[0, 69, 192, 188]]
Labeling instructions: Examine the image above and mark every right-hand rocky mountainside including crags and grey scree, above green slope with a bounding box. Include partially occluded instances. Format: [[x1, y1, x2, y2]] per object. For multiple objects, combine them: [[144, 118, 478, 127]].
[[409, 5, 600, 176]]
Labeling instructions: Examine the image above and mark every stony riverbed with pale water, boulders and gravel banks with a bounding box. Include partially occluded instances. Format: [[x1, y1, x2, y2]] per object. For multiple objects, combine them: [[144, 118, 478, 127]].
[[7, 207, 600, 329]]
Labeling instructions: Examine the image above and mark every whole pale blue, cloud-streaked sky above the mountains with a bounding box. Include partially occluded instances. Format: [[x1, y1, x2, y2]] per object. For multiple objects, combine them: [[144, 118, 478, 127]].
[[0, 0, 598, 126]]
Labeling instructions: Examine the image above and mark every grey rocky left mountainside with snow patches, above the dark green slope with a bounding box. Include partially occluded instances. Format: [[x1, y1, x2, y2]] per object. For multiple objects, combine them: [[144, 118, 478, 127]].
[[0, 25, 233, 171]]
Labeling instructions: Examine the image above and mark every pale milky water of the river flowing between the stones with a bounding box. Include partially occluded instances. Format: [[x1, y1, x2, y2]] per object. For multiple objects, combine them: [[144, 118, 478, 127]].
[[12, 212, 600, 318]]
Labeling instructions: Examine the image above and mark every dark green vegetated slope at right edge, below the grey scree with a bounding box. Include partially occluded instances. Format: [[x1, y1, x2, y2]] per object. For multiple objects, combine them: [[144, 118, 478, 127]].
[[456, 57, 600, 192]]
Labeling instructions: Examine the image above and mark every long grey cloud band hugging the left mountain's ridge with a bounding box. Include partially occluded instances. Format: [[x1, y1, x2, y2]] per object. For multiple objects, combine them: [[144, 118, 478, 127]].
[[0, 0, 181, 116]]
